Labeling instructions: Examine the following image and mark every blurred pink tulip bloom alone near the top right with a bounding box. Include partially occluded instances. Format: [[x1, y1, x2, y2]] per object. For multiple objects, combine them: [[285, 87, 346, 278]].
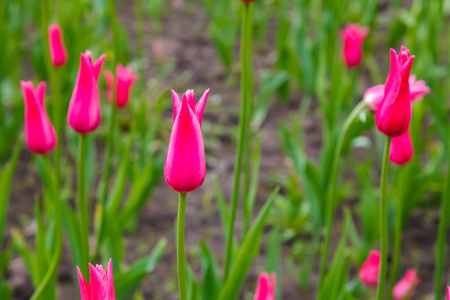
[[340, 24, 369, 68]]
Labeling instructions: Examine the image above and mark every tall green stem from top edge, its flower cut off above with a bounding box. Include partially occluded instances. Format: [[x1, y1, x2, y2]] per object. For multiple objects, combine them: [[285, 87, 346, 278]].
[[223, 3, 252, 282]]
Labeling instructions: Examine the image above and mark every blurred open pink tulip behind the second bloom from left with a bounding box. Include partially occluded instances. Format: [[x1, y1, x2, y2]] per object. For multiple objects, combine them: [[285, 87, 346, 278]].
[[103, 65, 137, 108]]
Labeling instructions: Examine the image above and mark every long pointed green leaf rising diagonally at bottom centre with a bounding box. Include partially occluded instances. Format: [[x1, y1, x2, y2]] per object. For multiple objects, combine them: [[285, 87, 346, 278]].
[[218, 188, 279, 300]]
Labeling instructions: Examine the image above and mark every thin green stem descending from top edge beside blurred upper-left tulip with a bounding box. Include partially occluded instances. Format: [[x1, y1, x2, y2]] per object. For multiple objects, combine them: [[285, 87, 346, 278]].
[[41, 0, 63, 184]]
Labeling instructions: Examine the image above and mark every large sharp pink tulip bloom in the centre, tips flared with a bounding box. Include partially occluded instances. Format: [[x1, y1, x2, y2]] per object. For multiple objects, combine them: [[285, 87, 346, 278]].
[[164, 89, 209, 193]]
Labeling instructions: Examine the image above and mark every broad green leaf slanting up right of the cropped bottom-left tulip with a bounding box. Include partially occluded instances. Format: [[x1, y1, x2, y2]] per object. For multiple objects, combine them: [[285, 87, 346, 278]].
[[114, 238, 167, 300]]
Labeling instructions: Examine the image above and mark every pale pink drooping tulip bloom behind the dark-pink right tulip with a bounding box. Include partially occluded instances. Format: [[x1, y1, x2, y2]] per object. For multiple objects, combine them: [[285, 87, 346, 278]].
[[363, 75, 430, 112]]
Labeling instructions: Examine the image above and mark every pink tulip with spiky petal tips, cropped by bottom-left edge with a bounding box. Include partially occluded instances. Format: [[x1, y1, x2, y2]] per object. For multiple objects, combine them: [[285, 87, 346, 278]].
[[77, 259, 116, 300]]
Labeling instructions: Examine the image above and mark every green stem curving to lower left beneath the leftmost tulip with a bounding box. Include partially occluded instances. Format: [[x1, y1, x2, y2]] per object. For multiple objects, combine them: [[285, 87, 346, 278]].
[[30, 156, 63, 300]]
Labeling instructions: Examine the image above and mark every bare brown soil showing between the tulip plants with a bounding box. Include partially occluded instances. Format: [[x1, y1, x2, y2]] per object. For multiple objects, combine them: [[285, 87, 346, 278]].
[[2, 1, 446, 300]]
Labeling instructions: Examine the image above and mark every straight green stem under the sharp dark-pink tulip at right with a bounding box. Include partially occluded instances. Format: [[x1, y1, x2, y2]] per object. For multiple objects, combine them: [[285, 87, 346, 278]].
[[376, 137, 392, 300]]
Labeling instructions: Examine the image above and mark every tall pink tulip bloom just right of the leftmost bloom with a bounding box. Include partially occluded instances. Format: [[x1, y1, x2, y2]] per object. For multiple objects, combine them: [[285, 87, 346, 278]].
[[67, 51, 106, 134]]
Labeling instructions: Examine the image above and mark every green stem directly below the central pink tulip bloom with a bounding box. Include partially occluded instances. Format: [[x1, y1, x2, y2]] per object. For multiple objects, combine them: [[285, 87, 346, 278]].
[[177, 193, 187, 300]]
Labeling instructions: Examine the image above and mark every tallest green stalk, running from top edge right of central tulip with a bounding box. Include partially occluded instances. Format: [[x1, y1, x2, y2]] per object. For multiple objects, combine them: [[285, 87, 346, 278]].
[[223, 2, 253, 281]]
